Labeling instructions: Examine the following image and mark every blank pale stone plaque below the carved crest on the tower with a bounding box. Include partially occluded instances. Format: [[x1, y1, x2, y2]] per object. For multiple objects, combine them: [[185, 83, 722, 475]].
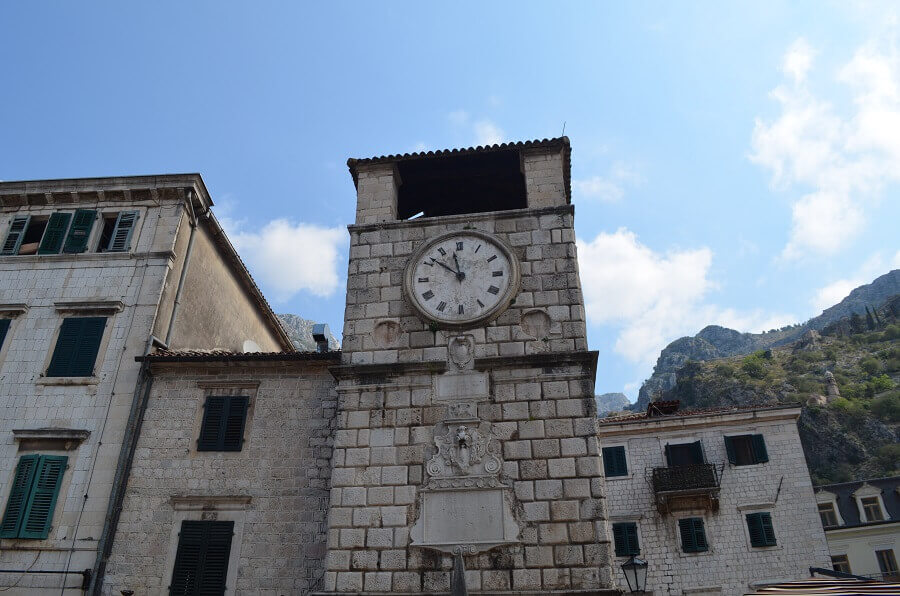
[[411, 488, 519, 553]]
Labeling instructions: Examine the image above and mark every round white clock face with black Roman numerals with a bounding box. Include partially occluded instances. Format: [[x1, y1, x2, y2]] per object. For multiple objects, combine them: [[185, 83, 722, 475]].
[[406, 231, 519, 326]]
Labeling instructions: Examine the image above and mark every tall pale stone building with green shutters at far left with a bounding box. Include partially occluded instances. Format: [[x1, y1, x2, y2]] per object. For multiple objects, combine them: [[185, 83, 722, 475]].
[[0, 174, 290, 594]]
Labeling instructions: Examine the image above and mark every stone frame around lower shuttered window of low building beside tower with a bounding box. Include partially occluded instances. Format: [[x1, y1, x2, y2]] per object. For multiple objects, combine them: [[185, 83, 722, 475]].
[[160, 495, 252, 596]]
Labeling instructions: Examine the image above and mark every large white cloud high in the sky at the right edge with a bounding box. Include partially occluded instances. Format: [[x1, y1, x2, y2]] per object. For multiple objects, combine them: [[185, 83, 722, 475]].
[[750, 39, 900, 259]]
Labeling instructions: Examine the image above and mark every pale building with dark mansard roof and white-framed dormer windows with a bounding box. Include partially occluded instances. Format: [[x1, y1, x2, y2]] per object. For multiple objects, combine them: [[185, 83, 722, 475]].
[[816, 476, 900, 581]]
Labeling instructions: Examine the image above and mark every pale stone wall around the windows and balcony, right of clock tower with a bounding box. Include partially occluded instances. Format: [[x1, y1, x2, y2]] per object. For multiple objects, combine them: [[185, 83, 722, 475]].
[[600, 410, 830, 594]]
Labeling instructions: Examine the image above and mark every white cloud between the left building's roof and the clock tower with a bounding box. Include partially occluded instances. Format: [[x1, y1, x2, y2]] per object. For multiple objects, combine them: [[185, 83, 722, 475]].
[[221, 208, 348, 302]]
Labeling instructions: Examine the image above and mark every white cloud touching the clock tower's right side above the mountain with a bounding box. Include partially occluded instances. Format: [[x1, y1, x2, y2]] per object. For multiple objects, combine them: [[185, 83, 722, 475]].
[[578, 228, 793, 366]]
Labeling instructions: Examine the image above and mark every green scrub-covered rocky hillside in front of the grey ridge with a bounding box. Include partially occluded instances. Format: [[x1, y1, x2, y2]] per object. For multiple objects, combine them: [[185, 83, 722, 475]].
[[659, 294, 900, 483]]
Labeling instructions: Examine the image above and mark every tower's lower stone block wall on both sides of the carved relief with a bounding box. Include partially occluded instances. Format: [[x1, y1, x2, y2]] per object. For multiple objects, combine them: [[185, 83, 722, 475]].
[[324, 353, 612, 593]]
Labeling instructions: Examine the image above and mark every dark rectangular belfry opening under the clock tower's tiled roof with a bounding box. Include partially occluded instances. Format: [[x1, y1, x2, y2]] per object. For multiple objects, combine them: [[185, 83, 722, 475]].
[[397, 150, 528, 219]]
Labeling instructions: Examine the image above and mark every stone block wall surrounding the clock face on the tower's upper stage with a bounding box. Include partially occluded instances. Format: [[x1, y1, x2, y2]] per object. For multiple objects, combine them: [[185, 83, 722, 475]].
[[342, 205, 587, 364]]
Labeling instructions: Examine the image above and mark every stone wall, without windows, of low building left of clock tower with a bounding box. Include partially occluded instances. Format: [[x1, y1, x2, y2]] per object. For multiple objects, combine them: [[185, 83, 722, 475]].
[[104, 361, 337, 594]]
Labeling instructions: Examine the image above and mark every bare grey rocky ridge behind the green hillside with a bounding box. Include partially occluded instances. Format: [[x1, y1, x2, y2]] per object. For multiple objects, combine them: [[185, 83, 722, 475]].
[[633, 269, 900, 411]]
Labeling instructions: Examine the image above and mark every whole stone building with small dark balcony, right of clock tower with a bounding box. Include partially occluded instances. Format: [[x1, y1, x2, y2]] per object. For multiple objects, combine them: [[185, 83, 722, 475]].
[[599, 402, 830, 594]]
